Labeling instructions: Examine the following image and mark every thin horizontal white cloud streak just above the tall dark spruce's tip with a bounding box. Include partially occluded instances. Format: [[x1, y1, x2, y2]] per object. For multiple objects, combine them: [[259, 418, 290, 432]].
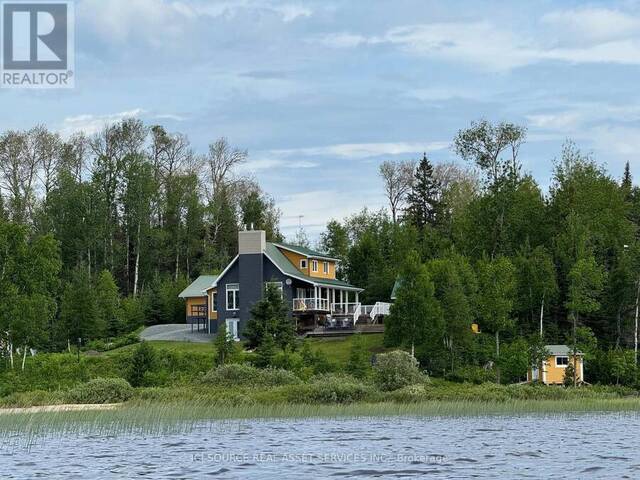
[[272, 142, 449, 159]]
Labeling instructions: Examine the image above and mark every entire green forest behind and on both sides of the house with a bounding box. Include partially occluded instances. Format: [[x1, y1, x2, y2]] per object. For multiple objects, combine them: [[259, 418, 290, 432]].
[[0, 119, 640, 385]]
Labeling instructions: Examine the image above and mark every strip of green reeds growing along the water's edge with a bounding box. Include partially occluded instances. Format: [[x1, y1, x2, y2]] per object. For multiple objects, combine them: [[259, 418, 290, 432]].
[[0, 398, 640, 438]]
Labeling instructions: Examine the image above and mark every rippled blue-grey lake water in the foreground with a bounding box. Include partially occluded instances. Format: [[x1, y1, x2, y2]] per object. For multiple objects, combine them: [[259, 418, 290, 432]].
[[0, 414, 640, 479]]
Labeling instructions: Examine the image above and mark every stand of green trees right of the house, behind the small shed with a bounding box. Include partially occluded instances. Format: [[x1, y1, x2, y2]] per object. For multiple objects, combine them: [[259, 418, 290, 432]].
[[321, 121, 640, 383]]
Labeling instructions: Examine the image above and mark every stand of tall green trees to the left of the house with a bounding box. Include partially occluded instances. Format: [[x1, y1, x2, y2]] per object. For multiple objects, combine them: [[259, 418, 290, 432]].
[[0, 119, 281, 360]]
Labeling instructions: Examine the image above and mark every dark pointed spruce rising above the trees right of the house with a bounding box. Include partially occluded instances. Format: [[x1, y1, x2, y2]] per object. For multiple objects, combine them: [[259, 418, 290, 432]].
[[407, 153, 442, 230]]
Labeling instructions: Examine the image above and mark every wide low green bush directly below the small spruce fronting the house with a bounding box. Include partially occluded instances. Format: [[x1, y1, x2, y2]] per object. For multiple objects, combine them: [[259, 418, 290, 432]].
[[202, 364, 301, 387]]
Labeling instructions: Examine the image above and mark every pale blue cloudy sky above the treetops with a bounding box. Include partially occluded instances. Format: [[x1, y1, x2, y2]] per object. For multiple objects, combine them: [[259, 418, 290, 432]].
[[0, 0, 640, 237]]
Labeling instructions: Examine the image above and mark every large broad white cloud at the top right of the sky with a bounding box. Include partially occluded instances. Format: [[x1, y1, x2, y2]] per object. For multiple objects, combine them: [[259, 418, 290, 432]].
[[312, 9, 640, 71]]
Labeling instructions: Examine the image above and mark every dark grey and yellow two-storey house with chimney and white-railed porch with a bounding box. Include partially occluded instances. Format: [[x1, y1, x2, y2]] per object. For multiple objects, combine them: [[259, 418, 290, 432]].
[[180, 230, 389, 338]]
